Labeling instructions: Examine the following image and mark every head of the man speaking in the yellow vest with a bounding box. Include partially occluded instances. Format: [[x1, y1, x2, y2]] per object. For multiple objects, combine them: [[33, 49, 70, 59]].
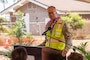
[[48, 6, 57, 20]]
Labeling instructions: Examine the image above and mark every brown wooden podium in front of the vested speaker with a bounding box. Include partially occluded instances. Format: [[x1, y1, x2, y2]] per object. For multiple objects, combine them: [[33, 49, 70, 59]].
[[14, 45, 62, 60]]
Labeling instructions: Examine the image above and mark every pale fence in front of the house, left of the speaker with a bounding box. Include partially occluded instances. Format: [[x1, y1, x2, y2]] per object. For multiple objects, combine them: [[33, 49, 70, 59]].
[[0, 22, 45, 35]]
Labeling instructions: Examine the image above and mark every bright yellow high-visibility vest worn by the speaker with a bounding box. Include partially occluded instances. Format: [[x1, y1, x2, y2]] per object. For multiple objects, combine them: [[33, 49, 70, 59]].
[[45, 19, 65, 50]]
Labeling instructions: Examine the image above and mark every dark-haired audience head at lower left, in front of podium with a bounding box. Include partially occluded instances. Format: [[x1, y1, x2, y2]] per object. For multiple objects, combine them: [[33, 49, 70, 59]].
[[11, 47, 27, 60]]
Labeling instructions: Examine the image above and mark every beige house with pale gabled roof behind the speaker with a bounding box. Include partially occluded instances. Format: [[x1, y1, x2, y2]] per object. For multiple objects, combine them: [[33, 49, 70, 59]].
[[0, 0, 90, 35]]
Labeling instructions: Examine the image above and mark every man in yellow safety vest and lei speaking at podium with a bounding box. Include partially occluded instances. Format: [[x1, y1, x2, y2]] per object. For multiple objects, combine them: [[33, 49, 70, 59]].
[[42, 6, 72, 60]]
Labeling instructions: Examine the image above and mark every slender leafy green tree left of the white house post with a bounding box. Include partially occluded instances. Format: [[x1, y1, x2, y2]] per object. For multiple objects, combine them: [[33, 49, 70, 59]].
[[10, 11, 26, 43]]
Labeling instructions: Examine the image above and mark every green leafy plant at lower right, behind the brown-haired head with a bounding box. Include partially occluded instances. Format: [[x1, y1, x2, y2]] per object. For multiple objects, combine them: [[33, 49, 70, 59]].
[[74, 42, 90, 60]]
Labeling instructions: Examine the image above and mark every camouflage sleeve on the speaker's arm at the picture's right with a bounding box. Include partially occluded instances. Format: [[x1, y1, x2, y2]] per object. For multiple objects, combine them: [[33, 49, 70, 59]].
[[62, 23, 72, 50]]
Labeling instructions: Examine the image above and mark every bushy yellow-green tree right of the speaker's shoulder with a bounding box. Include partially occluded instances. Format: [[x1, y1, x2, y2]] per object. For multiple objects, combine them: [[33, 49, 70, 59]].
[[61, 12, 85, 39]]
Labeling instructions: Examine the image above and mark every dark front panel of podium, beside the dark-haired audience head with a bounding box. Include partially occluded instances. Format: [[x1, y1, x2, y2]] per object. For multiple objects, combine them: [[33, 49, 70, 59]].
[[14, 45, 42, 60]]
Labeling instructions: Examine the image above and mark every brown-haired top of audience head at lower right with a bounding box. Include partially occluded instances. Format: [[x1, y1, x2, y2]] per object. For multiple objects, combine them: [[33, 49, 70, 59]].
[[67, 52, 84, 60]]
